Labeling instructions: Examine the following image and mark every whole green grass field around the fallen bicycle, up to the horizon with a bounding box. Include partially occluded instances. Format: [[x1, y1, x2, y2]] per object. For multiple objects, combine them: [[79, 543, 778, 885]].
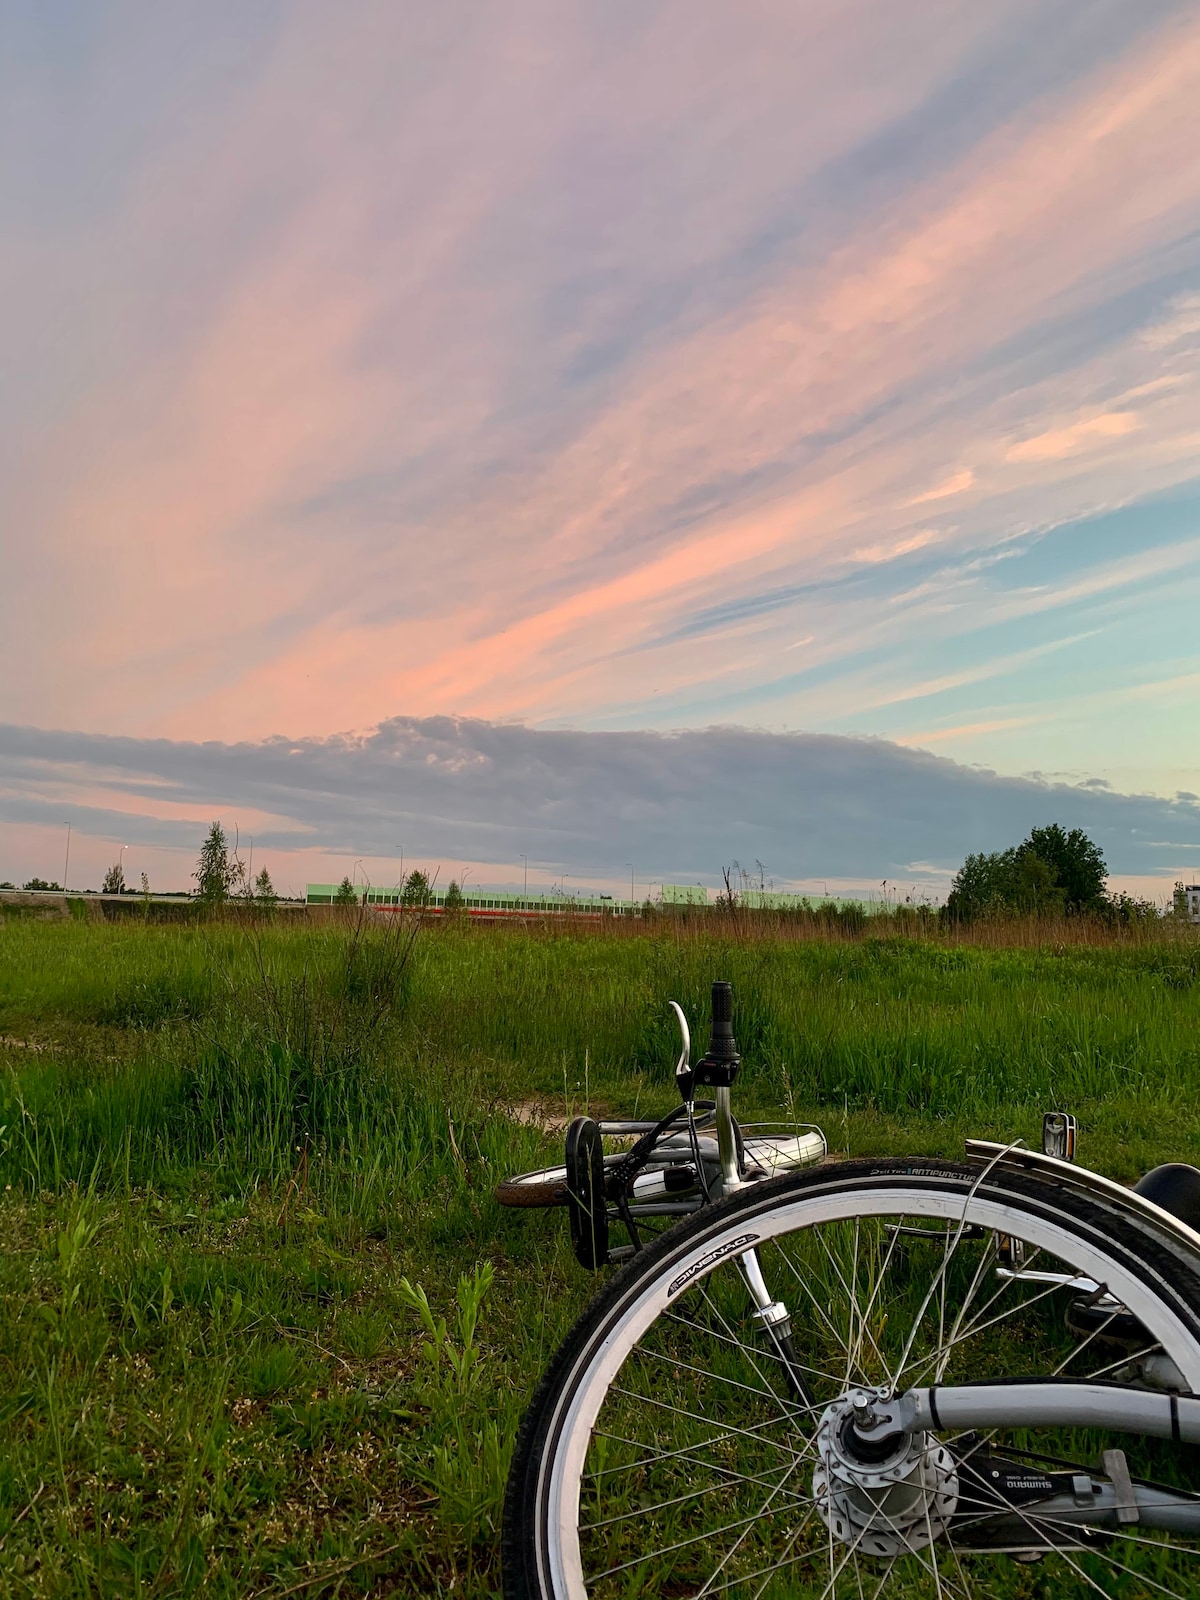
[[0, 918, 1200, 1600]]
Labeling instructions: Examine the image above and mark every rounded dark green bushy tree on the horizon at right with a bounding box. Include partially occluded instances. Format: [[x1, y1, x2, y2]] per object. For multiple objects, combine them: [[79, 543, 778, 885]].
[[946, 822, 1110, 922]]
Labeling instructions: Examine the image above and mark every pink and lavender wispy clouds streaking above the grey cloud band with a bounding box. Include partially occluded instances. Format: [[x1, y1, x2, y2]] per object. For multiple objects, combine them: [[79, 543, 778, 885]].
[[0, 0, 1200, 806]]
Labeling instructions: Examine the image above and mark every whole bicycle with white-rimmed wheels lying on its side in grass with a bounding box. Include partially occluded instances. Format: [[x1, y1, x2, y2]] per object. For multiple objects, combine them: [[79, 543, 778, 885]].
[[498, 984, 1200, 1600]]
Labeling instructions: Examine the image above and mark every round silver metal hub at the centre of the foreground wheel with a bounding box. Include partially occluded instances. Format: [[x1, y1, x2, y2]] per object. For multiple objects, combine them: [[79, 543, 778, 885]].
[[813, 1389, 958, 1557]]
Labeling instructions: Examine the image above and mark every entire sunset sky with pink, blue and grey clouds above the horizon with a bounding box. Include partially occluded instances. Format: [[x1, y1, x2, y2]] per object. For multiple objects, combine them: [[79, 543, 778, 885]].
[[0, 0, 1200, 891]]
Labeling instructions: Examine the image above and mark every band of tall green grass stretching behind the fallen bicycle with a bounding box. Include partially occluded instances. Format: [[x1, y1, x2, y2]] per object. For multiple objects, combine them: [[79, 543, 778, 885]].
[[0, 918, 1200, 1182]]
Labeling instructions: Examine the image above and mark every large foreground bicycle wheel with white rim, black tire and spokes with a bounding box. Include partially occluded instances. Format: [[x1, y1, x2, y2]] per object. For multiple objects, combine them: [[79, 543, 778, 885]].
[[504, 1162, 1200, 1600]]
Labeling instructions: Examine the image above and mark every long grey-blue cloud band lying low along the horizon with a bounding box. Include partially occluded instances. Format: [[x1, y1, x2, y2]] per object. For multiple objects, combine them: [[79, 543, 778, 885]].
[[0, 717, 1200, 880]]
